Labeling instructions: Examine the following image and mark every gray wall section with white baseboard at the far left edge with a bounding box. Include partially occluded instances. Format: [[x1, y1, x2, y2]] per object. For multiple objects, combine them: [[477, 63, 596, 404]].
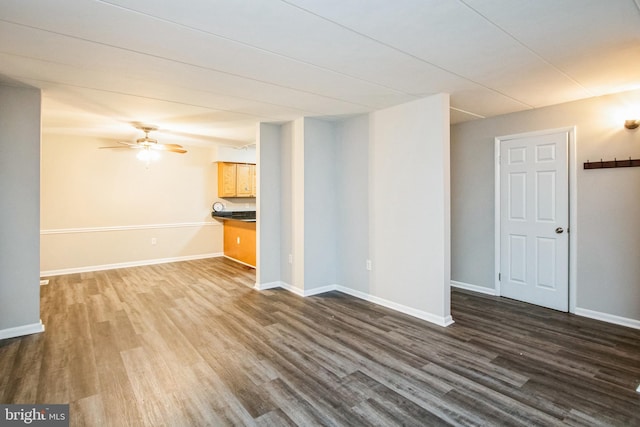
[[0, 85, 44, 339]]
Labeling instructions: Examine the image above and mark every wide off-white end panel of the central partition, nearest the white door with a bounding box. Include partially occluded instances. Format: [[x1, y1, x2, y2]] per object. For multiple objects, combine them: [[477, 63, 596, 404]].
[[369, 94, 451, 325]]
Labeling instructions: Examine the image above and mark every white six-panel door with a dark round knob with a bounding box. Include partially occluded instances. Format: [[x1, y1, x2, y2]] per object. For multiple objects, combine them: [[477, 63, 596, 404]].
[[500, 132, 569, 311]]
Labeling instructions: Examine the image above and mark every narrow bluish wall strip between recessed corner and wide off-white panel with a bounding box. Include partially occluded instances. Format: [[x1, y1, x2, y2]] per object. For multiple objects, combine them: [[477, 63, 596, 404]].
[[336, 115, 369, 294]]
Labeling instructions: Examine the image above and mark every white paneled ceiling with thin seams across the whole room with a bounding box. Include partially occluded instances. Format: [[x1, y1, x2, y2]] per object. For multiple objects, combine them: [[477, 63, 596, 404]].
[[0, 0, 640, 145]]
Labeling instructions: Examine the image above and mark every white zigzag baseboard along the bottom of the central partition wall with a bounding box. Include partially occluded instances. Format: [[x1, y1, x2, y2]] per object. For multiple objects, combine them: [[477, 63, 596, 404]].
[[254, 282, 454, 326]]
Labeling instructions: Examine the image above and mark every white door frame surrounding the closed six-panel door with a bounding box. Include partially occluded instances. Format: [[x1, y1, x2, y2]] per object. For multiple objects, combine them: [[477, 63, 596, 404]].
[[493, 126, 578, 313]]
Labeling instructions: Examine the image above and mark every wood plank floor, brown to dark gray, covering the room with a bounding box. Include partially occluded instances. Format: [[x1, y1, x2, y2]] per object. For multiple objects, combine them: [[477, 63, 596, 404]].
[[0, 258, 640, 426]]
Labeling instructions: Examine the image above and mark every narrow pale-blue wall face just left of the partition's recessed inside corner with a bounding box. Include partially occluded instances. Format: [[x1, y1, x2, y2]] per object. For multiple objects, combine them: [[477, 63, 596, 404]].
[[304, 118, 340, 293]]
